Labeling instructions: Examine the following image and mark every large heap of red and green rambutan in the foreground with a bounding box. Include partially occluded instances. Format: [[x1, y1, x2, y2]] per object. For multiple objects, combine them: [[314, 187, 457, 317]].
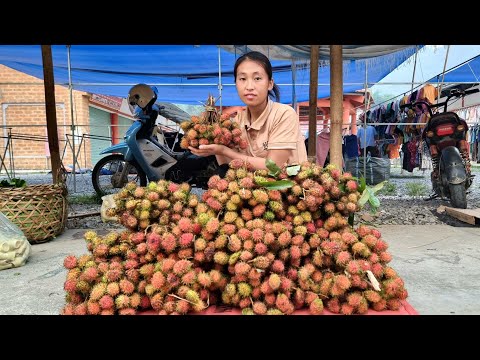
[[62, 160, 408, 315]]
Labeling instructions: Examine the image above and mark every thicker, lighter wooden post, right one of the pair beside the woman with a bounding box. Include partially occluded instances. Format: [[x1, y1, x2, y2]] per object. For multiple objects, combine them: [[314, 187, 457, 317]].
[[330, 45, 343, 169]]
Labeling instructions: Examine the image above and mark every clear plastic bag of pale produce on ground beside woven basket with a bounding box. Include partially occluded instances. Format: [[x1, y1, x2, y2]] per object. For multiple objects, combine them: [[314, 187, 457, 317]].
[[0, 212, 31, 270]]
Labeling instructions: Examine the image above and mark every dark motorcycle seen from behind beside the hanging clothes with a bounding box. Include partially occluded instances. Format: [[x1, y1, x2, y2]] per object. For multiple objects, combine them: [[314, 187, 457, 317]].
[[400, 89, 479, 209]]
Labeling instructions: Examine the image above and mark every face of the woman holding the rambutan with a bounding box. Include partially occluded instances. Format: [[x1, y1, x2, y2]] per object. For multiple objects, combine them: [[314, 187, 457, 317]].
[[236, 60, 273, 106]]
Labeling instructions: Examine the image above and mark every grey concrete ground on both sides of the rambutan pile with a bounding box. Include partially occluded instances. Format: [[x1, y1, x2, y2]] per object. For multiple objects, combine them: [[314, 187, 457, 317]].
[[0, 225, 480, 315]]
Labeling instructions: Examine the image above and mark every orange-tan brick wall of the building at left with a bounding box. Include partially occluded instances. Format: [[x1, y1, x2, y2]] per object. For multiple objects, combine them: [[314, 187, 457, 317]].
[[0, 65, 92, 170]]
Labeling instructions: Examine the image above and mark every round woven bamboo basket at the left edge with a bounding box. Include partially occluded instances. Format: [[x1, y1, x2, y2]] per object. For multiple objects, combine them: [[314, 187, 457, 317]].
[[0, 184, 67, 244]]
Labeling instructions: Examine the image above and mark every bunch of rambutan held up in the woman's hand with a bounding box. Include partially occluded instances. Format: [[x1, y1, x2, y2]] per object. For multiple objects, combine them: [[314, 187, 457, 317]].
[[180, 95, 247, 149]]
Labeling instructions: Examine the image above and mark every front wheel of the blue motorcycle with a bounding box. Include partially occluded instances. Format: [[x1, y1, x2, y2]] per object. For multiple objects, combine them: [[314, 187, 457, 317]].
[[92, 154, 147, 197]]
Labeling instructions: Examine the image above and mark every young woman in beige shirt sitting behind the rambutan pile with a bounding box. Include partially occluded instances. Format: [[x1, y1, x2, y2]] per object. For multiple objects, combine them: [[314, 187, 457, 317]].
[[189, 51, 307, 169]]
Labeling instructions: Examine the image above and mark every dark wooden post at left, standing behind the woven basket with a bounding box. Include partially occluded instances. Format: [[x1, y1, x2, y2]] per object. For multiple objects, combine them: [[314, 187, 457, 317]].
[[42, 45, 61, 183]]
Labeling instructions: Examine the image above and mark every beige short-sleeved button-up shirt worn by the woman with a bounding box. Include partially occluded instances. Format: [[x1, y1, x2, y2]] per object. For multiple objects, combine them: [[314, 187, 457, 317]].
[[235, 99, 307, 164]]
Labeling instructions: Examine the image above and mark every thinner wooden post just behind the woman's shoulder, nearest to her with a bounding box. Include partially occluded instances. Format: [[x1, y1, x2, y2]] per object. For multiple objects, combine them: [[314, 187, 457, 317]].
[[307, 45, 319, 163]]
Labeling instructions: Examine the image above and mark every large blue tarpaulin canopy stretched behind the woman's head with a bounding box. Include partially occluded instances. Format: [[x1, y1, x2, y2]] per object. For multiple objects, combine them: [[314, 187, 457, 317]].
[[0, 45, 415, 106]]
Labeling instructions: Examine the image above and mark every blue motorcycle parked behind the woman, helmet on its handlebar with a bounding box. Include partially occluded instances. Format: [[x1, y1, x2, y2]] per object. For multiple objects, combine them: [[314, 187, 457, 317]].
[[92, 84, 218, 196]]
